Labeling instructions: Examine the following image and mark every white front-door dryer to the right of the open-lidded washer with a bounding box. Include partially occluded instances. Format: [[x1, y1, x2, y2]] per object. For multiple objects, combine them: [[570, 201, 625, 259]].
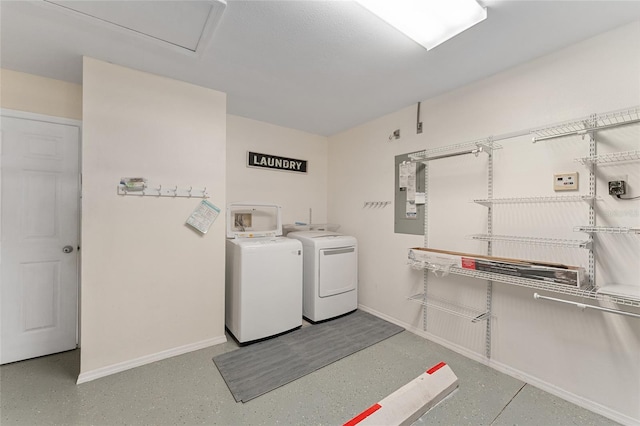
[[287, 231, 358, 322]]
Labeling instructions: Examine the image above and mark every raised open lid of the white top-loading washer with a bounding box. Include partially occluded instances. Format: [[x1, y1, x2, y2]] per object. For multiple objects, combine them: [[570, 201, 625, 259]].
[[227, 202, 282, 238]]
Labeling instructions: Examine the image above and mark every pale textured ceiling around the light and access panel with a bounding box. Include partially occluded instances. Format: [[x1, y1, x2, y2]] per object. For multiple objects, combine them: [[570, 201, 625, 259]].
[[0, 0, 640, 135]]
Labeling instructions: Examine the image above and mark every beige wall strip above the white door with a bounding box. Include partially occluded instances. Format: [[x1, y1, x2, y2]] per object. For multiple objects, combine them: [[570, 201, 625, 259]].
[[0, 69, 82, 120]]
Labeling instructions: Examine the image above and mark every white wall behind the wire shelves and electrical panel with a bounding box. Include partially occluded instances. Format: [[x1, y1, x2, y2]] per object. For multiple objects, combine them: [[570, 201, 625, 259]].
[[328, 22, 640, 424]]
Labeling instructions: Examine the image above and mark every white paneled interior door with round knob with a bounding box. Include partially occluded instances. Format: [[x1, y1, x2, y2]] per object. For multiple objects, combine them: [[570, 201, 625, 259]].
[[0, 117, 80, 364]]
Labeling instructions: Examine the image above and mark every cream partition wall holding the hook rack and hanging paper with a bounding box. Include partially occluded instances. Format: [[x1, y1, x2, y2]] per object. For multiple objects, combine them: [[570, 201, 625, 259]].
[[79, 58, 226, 382]]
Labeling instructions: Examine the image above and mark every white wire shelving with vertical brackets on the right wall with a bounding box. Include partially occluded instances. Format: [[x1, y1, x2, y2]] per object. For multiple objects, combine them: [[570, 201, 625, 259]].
[[408, 106, 640, 358]]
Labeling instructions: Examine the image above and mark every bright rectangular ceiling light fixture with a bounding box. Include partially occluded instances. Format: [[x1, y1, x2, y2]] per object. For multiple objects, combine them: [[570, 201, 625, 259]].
[[356, 0, 487, 50]]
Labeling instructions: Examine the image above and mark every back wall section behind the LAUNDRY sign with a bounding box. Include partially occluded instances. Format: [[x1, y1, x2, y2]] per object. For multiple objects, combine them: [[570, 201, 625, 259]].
[[227, 115, 328, 224]]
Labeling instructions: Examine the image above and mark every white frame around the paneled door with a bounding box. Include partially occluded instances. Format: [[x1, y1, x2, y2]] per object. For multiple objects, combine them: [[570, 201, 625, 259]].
[[0, 108, 82, 347]]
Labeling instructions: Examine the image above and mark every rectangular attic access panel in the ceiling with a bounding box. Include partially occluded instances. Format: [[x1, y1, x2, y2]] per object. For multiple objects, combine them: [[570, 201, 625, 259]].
[[44, 0, 226, 53]]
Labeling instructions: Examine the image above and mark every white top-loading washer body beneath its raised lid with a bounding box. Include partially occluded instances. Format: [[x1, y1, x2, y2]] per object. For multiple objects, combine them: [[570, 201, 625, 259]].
[[225, 204, 302, 343]]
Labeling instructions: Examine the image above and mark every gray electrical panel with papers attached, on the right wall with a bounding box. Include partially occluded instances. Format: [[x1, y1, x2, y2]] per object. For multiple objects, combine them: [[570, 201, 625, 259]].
[[393, 153, 426, 235]]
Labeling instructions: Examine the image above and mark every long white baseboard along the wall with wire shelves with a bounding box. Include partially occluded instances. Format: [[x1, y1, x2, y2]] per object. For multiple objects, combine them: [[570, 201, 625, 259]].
[[358, 305, 640, 426]]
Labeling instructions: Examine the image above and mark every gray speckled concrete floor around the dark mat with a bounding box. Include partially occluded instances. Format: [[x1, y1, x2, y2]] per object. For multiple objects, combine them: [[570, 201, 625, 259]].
[[0, 331, 616, 426]]
